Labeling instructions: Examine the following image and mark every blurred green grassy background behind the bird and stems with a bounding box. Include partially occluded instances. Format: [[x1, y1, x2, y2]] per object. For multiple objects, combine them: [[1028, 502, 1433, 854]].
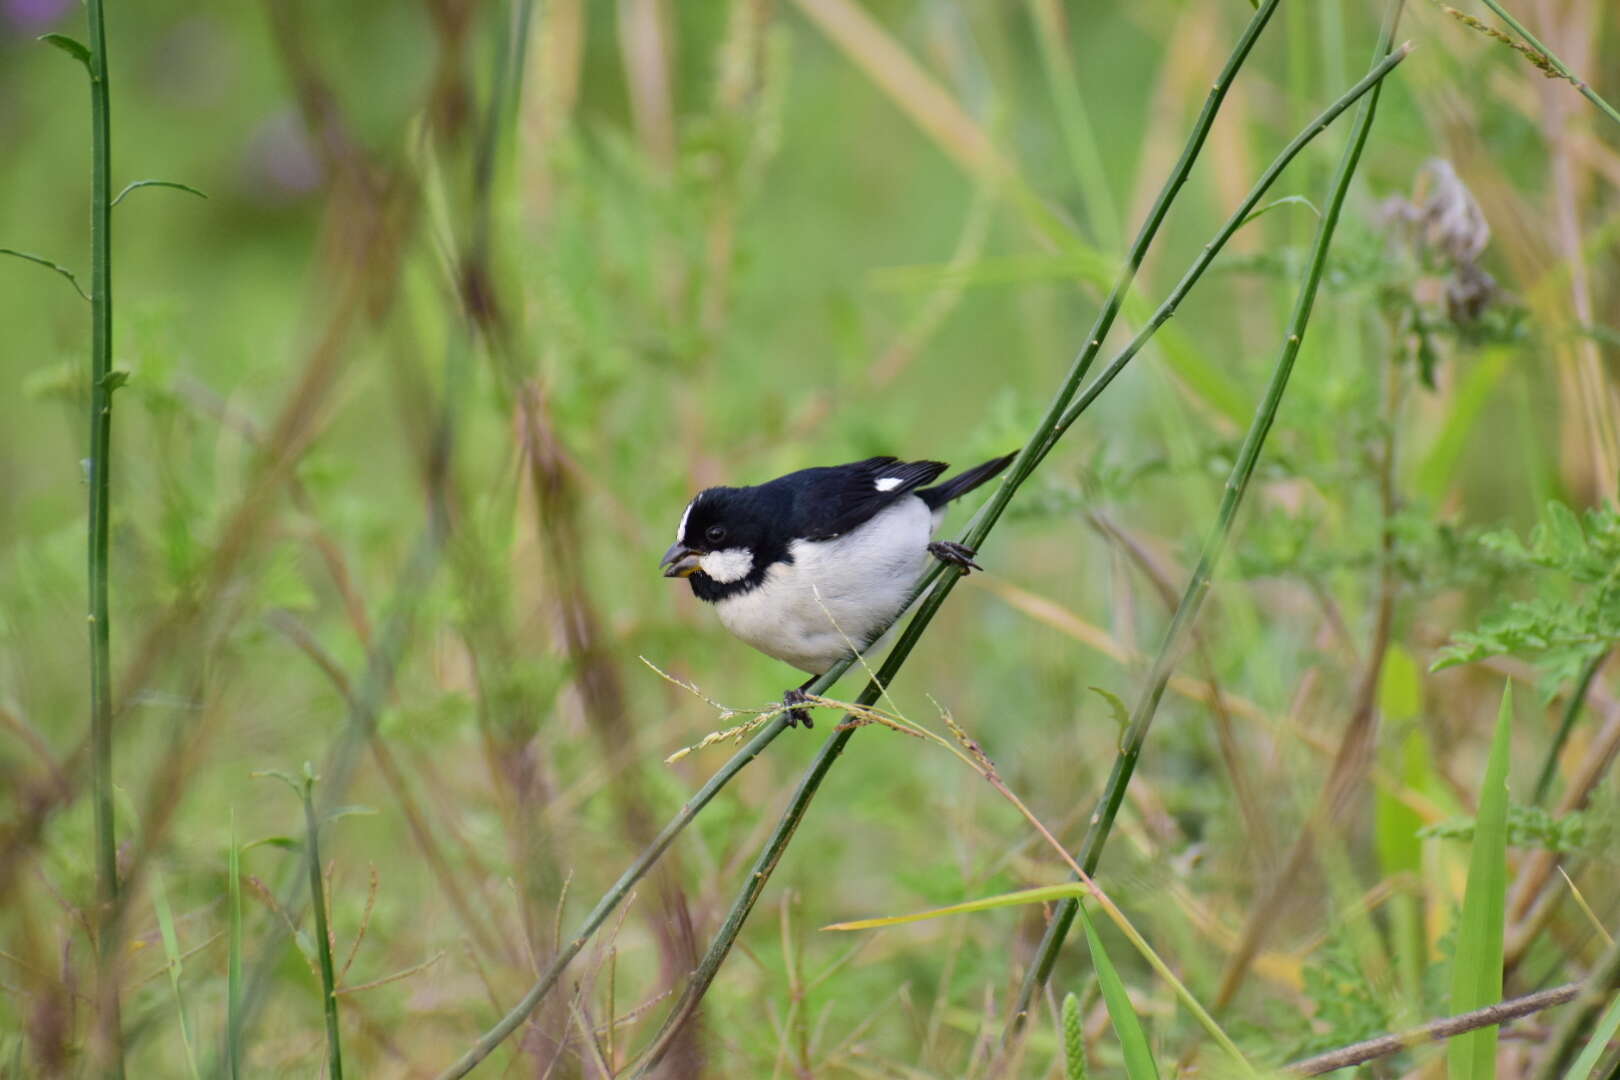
[[0, 0, 1620, 1077]]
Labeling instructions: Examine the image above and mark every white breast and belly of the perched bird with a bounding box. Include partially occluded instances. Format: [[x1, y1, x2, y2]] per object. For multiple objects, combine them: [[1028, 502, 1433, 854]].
[[714, 495, 936, 675]]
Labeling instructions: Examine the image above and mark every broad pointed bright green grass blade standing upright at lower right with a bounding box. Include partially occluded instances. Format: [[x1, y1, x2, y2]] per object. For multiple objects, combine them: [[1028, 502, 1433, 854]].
[[1447, 683, 1513, 1080]]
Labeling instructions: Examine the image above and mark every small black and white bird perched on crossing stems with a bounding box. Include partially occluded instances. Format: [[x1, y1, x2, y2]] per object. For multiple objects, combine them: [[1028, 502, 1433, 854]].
[[661, 453, 1014, 727]]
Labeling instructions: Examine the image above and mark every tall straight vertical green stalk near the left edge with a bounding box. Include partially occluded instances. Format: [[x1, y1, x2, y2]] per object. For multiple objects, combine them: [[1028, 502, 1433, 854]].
[[86, 0, 123, 1077]]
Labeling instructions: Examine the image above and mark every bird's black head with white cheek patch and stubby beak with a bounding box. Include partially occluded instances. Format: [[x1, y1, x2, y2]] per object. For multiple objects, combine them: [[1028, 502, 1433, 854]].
[[659, 487, 792, 602]]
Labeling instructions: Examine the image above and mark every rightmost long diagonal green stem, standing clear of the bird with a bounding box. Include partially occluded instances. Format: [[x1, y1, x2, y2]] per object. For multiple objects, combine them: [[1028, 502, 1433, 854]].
[[1006, 0, 1401, 1038]]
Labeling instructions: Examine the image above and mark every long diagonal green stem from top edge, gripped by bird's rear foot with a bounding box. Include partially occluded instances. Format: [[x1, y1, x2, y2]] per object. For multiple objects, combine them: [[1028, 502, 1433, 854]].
[[622, 0, 1277, 1077]]
